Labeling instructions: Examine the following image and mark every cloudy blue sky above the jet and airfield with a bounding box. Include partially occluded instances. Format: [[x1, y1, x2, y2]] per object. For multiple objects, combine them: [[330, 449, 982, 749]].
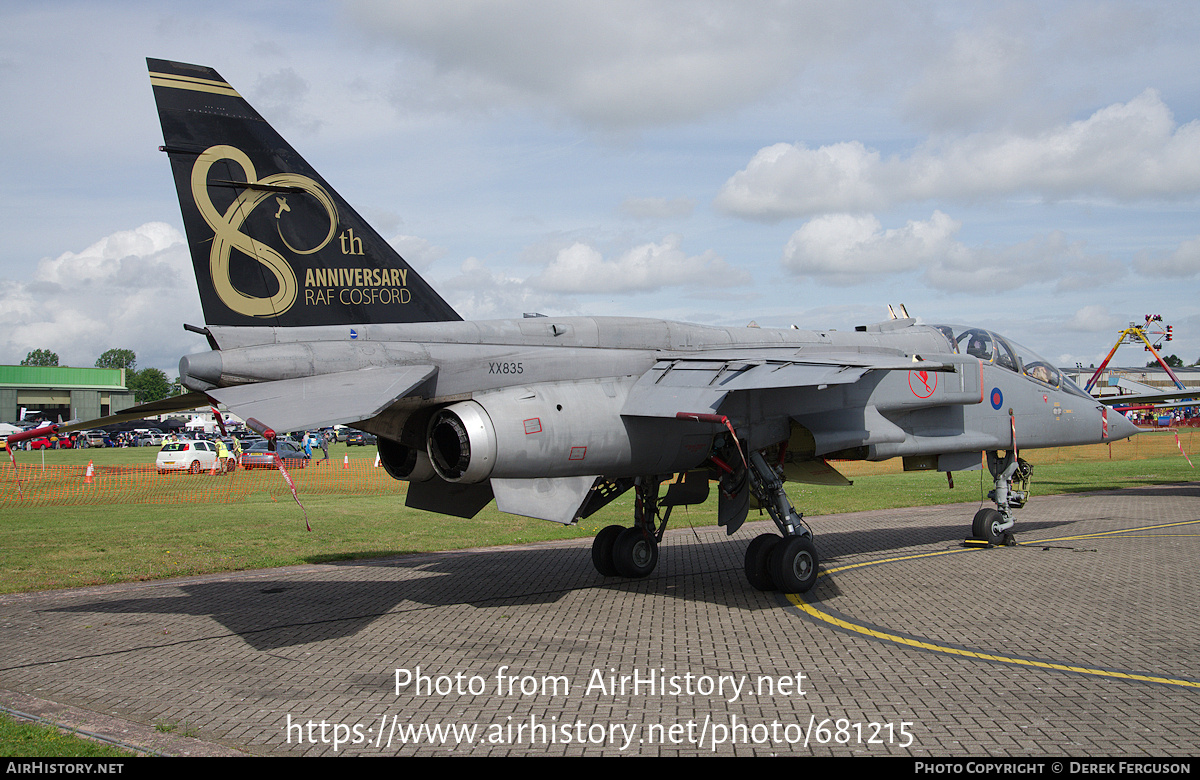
[[0, 0, 1200, 374]]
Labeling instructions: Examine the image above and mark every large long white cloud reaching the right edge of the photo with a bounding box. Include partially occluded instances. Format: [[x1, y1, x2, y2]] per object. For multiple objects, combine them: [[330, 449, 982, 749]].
[[716, 90, 1200, 220]]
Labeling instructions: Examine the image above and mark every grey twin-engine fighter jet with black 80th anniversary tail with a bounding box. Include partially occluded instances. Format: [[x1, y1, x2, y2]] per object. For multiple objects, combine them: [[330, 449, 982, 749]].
[[9, 60, 1136, 593]]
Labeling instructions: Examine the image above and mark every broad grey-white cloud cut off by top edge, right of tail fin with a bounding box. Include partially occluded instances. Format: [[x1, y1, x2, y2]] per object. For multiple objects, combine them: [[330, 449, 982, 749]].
[[348, 0, 864, 127]]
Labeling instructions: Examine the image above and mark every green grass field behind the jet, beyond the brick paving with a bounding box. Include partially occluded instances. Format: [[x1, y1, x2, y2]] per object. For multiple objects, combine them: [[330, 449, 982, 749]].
[[0, 432, 1200, 593]]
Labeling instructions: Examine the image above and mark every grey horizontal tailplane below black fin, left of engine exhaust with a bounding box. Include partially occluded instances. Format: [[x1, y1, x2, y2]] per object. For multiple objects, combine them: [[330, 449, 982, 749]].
[[206, 365, 437, 431]]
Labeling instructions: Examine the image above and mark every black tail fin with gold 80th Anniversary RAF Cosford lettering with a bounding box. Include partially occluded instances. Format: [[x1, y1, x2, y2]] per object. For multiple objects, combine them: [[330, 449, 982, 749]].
[[146, 59, 453, 328]]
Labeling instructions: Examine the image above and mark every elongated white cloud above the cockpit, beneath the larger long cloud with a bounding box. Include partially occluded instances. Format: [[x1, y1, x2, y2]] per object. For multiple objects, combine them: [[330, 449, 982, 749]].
[[782, 211, 1123, 293]]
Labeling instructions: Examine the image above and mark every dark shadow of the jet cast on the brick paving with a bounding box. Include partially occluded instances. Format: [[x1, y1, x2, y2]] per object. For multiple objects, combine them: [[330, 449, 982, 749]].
[[44, 485, 1200, 650]]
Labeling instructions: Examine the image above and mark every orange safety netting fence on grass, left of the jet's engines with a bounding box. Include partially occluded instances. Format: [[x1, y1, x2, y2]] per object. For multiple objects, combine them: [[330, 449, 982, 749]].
[[0, 460, 407, 508]]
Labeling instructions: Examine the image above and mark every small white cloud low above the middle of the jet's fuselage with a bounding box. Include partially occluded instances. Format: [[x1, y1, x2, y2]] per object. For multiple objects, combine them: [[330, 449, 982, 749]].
[[530, 234, 750, 293]]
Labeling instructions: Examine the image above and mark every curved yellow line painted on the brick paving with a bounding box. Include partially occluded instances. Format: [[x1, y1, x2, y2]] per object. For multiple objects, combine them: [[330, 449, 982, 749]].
[[787, 520, 1200, 689]]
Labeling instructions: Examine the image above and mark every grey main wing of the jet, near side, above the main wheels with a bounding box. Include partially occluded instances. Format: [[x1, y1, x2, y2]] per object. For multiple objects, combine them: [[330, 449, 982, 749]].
[[620, 350, 954, 418]]
